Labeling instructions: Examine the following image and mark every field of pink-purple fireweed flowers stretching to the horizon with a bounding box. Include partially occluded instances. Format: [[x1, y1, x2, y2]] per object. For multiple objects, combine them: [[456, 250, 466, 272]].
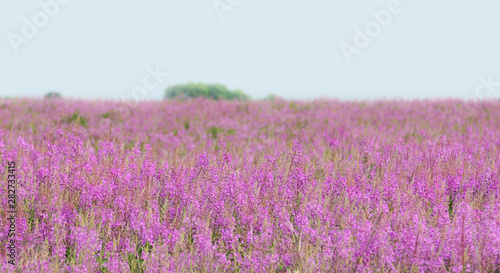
[[0, 99, 500, 272]]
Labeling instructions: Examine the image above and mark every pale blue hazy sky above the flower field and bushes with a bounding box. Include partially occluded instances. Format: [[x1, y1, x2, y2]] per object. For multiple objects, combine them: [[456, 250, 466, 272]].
[[0, 0, 500, 99]]
